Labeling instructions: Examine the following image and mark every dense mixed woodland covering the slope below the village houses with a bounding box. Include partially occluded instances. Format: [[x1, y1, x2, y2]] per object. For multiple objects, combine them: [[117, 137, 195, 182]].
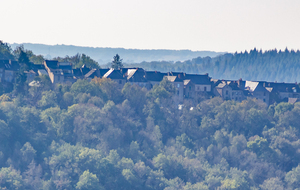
[[0, 73, 300, 190]]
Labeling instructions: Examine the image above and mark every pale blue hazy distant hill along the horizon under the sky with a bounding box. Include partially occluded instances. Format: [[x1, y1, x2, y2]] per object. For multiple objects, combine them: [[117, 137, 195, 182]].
[[10, 43, 225, 65]]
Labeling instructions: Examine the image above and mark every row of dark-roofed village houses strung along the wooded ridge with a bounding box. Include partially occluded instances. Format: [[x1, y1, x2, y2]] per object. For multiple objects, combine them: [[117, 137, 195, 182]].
[[0, 60, 300, 105]]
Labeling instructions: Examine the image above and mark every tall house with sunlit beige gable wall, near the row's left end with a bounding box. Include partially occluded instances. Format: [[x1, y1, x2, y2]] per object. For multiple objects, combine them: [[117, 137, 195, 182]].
[[43, 60, 76, 84]]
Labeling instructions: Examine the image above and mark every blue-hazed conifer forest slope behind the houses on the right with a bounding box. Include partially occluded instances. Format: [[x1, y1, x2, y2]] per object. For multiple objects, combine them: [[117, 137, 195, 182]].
[[126, 49, 300, 82]]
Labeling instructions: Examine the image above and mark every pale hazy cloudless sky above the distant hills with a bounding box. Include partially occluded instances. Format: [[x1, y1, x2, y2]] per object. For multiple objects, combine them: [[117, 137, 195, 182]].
[[0, 0, 300, 52]]
